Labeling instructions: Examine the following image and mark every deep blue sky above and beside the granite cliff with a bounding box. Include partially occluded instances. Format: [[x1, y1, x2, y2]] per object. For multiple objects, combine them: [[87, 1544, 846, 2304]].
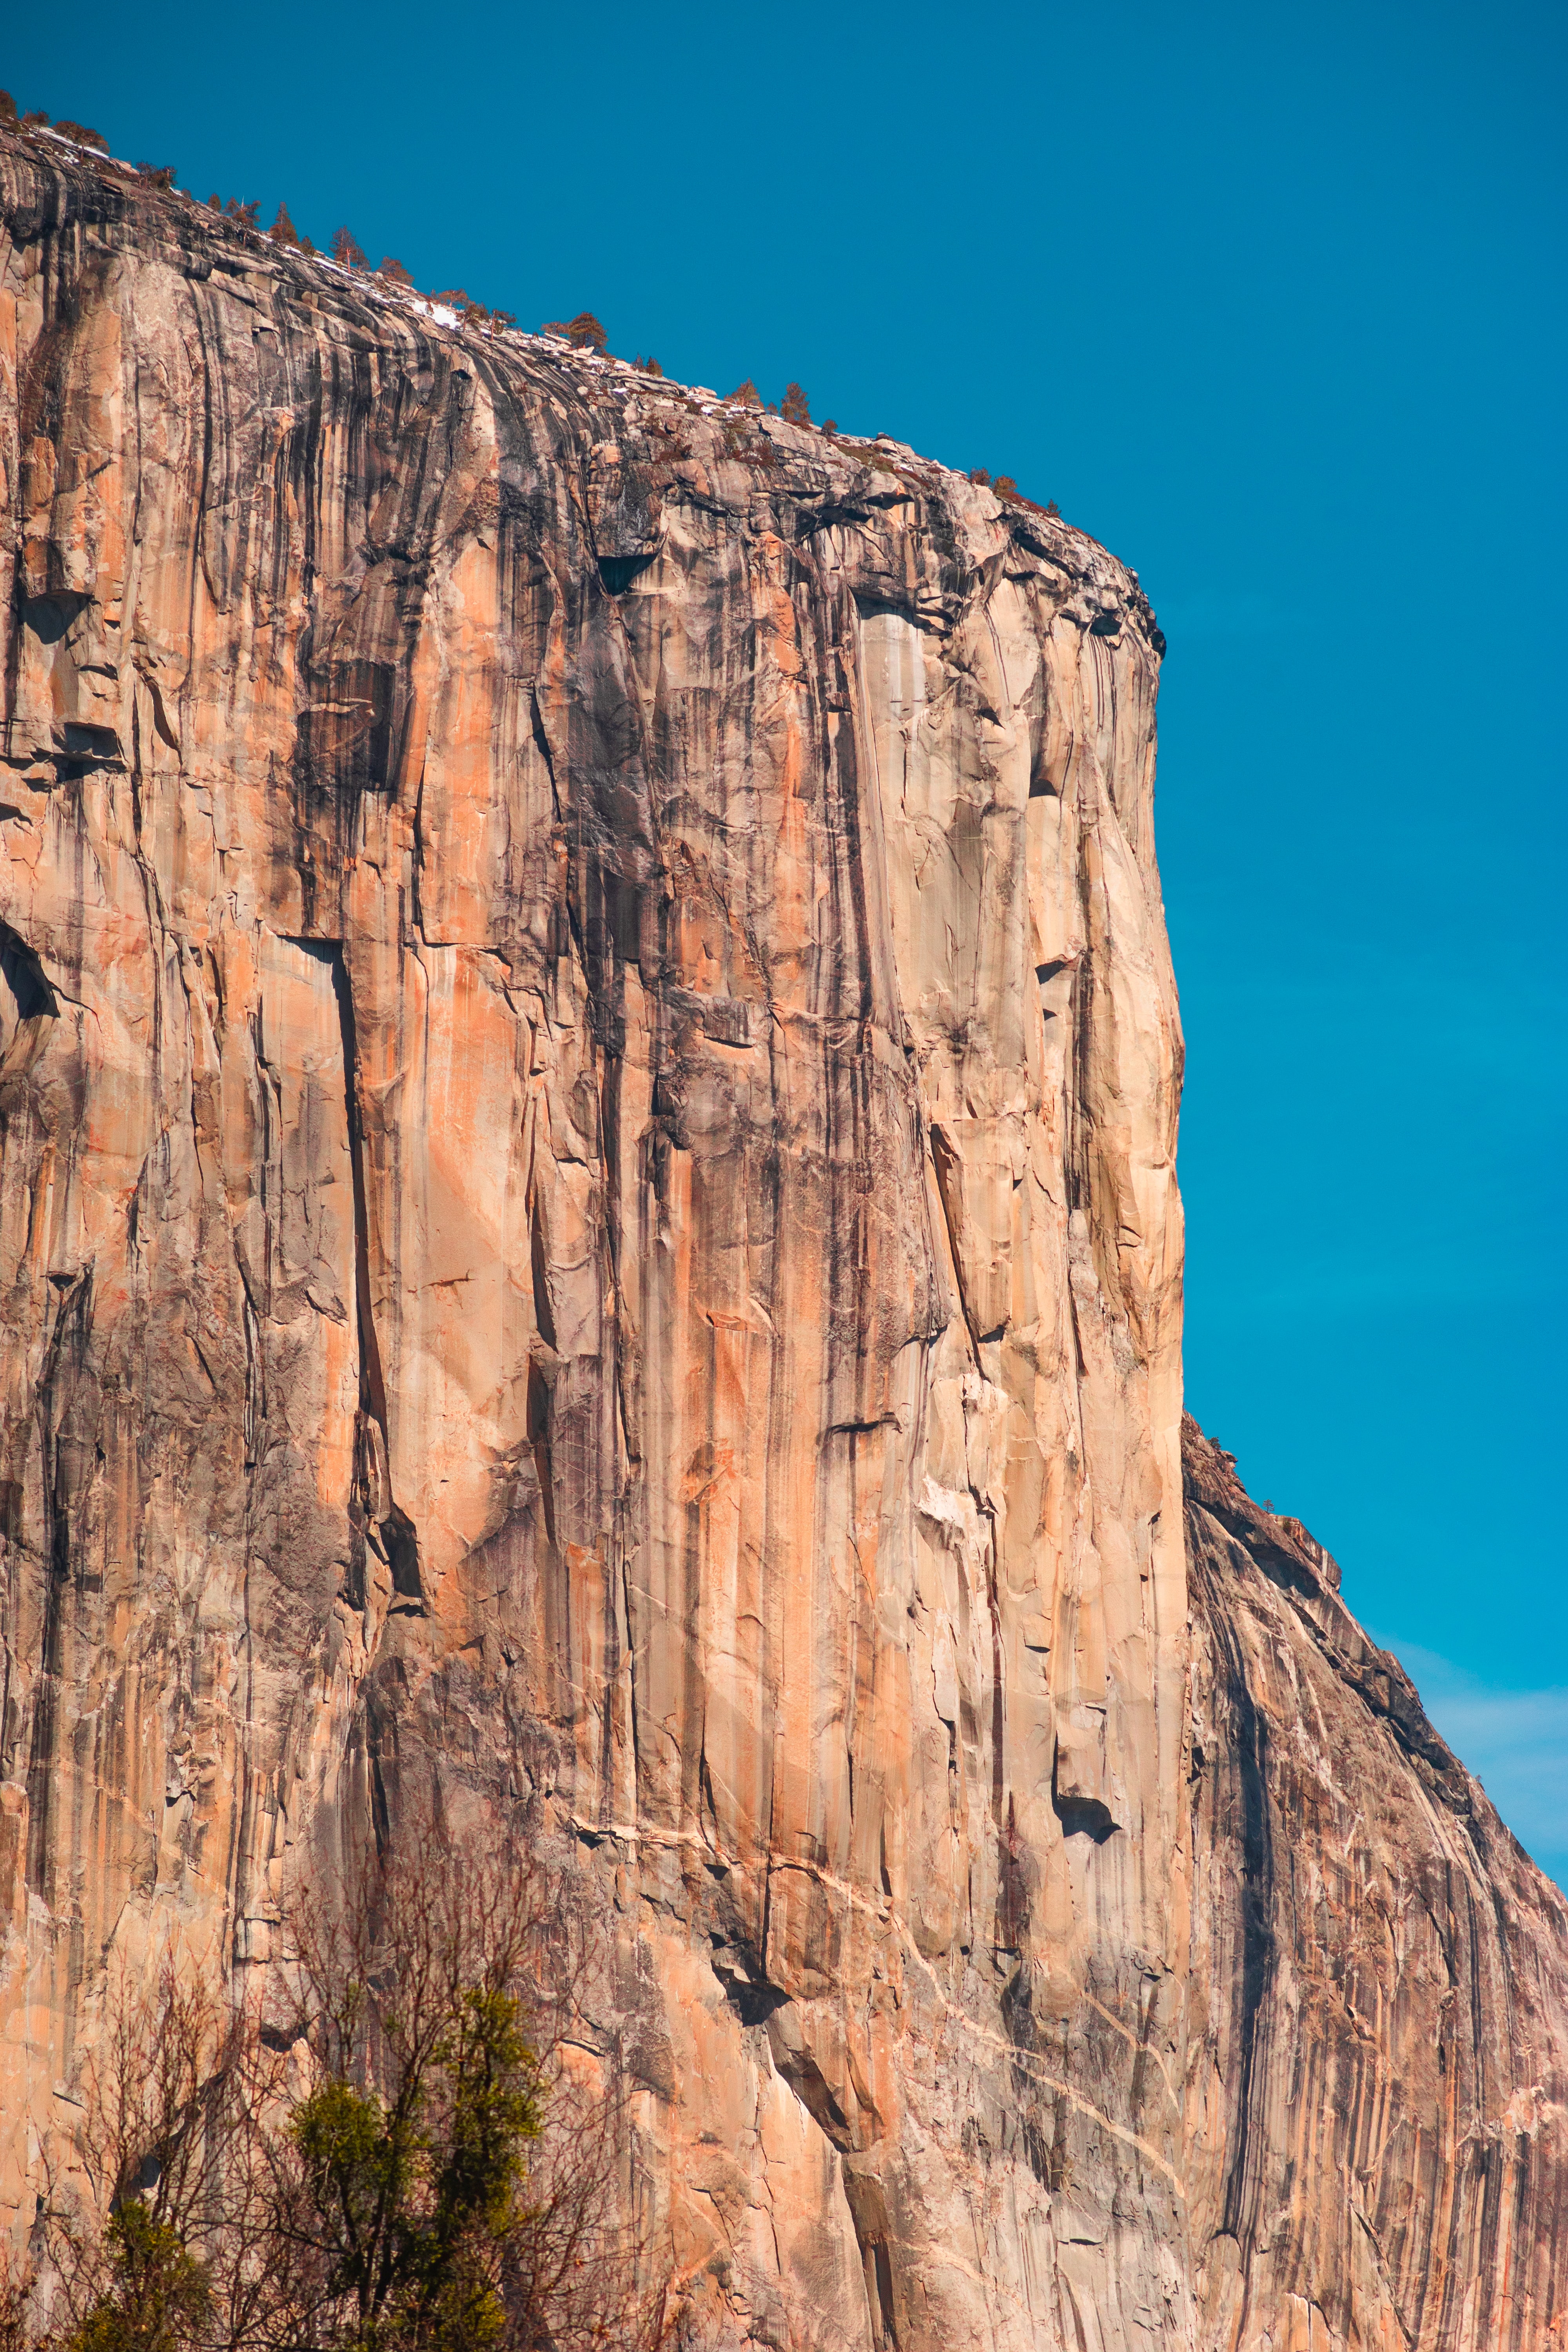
[[12, 0, 1568, 1879]]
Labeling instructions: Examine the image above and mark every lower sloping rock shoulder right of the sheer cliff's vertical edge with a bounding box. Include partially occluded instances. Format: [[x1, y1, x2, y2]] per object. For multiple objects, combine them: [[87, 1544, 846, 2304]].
[[1182, 1421, 1568, 2352]]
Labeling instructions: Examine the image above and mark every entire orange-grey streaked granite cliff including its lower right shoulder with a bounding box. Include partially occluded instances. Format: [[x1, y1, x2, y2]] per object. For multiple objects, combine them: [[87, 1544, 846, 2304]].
[[0, 139, 1568, 2352]]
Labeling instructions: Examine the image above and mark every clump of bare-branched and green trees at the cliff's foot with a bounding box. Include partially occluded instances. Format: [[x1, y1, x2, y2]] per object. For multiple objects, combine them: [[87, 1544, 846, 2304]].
[[17, 1837, 675, 2352]]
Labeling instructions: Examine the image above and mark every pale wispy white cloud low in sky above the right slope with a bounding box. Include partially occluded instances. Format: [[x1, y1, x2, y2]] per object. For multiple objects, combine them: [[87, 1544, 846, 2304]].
[[1373, 1635, 1568, 1891]]
